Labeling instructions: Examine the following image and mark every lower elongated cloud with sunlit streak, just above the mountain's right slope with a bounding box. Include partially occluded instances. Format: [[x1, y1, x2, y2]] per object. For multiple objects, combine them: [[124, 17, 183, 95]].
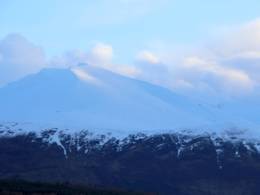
[[135, 50, 256, 96]]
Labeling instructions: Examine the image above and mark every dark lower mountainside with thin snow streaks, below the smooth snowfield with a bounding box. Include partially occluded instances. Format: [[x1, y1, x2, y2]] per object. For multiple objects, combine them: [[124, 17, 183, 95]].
[[0, 129, 260, 195]]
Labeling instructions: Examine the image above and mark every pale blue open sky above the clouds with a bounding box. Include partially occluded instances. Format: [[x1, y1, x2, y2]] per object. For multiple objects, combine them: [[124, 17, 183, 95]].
[[0, 0, 260, 61]]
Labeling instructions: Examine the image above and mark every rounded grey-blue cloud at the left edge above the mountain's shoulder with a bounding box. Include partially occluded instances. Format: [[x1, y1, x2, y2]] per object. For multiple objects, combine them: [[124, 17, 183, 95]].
[[0, 34, 46, 86]]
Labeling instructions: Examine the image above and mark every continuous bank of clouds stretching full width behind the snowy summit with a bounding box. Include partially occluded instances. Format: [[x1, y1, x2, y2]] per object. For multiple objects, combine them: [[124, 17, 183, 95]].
[[0, 19, 260, 96]]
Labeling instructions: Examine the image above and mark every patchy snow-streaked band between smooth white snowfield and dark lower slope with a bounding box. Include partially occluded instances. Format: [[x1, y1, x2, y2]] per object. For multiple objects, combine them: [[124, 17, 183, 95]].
[[0, 123, 260, 169]]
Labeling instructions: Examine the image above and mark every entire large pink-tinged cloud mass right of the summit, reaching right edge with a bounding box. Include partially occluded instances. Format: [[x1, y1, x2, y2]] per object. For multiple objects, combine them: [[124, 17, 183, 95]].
[[134, 19, 260, 96]]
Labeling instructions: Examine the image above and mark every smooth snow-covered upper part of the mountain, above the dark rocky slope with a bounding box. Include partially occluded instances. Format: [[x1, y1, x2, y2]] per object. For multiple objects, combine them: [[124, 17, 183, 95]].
[[0, 65, 260, 133]]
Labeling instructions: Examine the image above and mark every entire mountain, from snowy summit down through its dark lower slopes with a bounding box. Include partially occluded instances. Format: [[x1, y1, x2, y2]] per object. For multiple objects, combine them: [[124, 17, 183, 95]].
[[0, 65, 260, 195]]
